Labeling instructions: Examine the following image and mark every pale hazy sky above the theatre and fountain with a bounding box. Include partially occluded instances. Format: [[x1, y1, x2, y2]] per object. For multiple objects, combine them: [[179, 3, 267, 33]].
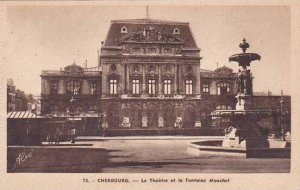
[[4, 5, 291, 95]]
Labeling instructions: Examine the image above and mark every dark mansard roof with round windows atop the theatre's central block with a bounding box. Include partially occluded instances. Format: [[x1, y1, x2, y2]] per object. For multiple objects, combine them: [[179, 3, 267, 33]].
[[104, 19, 198, 49]]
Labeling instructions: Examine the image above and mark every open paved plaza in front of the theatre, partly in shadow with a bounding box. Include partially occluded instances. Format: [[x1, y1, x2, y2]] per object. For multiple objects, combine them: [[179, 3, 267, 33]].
[[8, 137, 290, 173]]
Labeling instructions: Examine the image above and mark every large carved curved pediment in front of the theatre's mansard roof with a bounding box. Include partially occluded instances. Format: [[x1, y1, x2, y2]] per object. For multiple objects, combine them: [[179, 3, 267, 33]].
[[119, 26, 184, 43]]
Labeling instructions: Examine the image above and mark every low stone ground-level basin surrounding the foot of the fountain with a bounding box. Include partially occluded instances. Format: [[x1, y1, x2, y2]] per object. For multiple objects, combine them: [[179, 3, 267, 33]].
[[187, 140, 291, 158]]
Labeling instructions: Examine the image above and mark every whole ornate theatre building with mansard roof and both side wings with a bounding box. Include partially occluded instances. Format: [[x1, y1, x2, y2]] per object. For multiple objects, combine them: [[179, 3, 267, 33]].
[[41, 19, 290, 135]]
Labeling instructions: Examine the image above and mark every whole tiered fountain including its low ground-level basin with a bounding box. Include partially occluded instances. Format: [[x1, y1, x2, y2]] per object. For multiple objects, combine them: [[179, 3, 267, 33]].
[[188, 39, 290, 157]]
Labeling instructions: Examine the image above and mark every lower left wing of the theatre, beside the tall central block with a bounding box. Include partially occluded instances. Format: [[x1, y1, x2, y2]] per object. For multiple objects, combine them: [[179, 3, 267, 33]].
[[41, 63, 101, 115]]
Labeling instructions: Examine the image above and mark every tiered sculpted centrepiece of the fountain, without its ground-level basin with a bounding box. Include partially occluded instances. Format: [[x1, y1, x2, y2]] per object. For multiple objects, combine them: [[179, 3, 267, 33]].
[[216, 39, 269, 149]]
